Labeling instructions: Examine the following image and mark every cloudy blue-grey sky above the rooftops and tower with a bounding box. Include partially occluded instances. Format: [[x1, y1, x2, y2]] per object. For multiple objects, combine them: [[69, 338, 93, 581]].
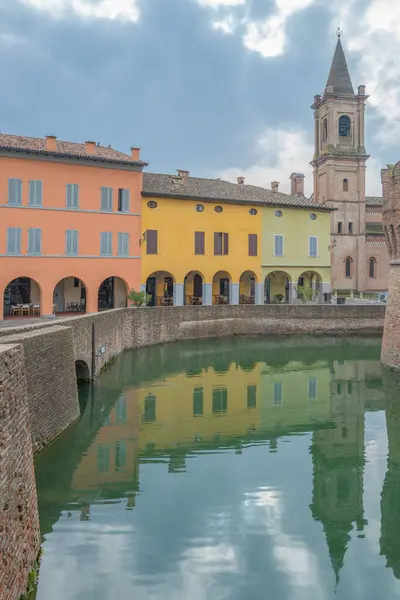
[[0, 0, 400, 195]]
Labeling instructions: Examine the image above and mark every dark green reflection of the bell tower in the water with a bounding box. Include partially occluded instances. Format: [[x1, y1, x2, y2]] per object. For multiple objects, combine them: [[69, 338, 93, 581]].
[[311, 382, 364, 582]]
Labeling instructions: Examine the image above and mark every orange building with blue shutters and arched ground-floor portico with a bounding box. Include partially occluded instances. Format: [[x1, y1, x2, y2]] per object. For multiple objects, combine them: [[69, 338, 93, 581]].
[[0, 134, 147, 318]]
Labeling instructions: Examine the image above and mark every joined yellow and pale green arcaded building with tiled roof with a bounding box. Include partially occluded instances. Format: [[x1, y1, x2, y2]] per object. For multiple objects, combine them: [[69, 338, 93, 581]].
[[141, 171, 331, 306]]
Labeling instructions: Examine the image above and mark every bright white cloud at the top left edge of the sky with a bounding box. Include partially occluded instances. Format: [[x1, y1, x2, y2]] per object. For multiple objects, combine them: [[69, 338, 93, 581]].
[[20, 0, 139, 22]]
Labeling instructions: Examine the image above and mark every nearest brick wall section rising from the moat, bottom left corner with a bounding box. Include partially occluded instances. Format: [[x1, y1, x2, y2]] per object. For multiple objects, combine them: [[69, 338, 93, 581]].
[[0, 345, 40, 600]]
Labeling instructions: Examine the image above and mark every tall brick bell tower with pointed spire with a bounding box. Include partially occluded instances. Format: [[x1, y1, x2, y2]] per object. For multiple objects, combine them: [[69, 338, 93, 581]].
[[311, 30, 369, 291]]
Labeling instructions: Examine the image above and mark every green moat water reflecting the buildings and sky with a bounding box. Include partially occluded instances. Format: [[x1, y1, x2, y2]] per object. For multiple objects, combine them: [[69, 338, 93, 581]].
[[36, 338, 400, 600]]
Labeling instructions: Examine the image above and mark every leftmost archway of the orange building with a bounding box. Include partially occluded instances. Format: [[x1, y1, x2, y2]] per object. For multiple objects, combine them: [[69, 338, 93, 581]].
[[3, 277, 42, 318]]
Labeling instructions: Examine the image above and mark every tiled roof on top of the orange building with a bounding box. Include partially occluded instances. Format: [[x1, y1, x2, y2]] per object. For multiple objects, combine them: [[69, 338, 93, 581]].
[[0, 133, 147, 167]]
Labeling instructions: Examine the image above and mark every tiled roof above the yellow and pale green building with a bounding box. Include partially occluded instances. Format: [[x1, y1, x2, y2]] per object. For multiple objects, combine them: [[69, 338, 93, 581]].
[[142, 173, 332, 211]]
